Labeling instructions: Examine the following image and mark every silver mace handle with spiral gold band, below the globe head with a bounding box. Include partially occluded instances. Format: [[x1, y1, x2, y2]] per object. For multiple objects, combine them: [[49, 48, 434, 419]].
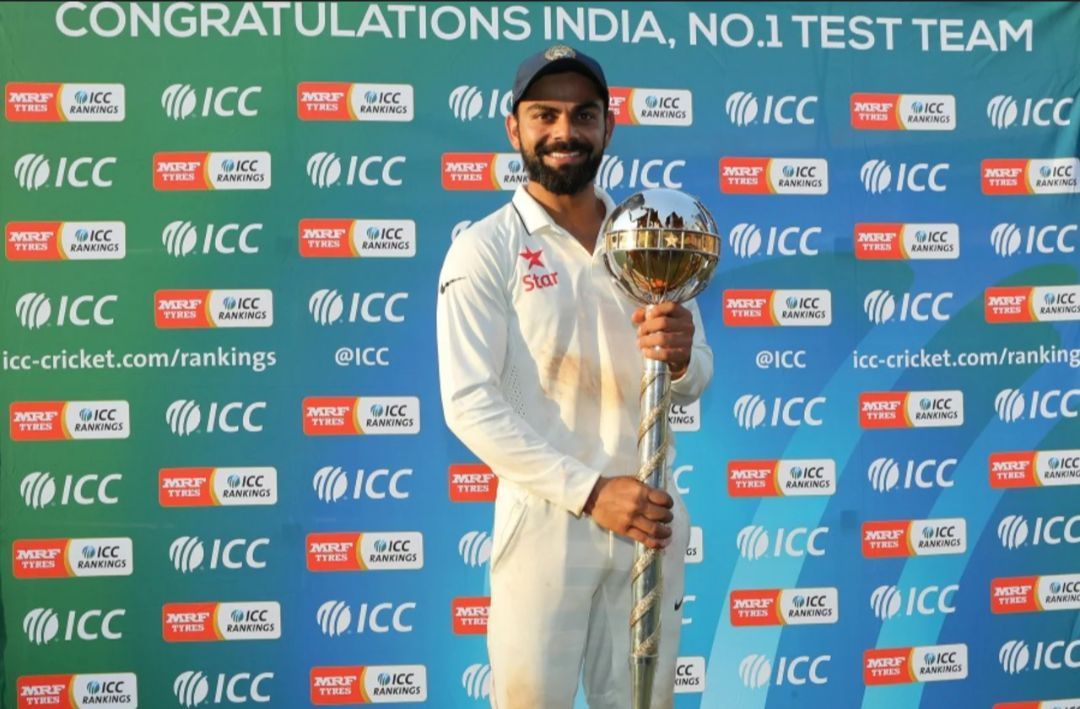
[[630, 352, 672, 709]]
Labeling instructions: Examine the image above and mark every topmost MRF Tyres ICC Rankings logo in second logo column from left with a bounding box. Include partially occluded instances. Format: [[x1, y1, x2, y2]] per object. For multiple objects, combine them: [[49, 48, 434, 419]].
[[153, 151, 270, 191]]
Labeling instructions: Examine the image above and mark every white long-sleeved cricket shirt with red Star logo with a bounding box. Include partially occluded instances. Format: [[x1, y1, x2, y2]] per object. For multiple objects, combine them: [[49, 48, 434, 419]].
[[436, 182, 713, 516]]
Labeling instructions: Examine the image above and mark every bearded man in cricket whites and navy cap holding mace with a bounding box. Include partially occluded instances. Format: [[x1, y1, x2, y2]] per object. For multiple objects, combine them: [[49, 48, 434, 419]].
[[437, 45, 713, 709]]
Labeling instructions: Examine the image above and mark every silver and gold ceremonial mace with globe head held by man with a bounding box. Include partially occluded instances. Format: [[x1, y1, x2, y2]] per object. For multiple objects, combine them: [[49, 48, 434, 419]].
[[604, 189, 720, 709]]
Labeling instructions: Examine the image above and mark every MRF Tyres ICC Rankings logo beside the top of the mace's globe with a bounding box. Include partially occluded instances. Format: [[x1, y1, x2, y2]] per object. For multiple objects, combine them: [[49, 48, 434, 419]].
[[720, 157, 828, 195]]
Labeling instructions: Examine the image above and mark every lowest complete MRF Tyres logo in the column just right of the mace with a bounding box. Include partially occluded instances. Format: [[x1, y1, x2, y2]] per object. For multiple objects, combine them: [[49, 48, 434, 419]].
[[728, 587, 840, 627]]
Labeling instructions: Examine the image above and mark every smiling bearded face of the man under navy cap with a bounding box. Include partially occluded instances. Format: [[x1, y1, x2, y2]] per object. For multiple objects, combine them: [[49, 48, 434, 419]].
[[507, 71, 615, 195]]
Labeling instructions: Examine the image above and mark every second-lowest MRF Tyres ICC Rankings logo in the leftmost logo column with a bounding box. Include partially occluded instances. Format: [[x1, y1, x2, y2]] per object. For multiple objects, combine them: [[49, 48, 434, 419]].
[[12, 537, 135, 578]]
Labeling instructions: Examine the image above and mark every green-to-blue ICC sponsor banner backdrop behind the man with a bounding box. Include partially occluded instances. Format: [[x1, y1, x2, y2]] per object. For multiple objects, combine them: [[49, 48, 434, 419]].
[[0, 2, 1080, 709]]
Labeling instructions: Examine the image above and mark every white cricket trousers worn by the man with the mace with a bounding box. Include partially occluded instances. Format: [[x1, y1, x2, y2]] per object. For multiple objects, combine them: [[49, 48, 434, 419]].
[[487, 480, 690, 709]]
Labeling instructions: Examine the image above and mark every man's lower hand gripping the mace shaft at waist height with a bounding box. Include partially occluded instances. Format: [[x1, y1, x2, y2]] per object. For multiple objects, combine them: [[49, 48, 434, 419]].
[[584, 476, 675, 549]]
